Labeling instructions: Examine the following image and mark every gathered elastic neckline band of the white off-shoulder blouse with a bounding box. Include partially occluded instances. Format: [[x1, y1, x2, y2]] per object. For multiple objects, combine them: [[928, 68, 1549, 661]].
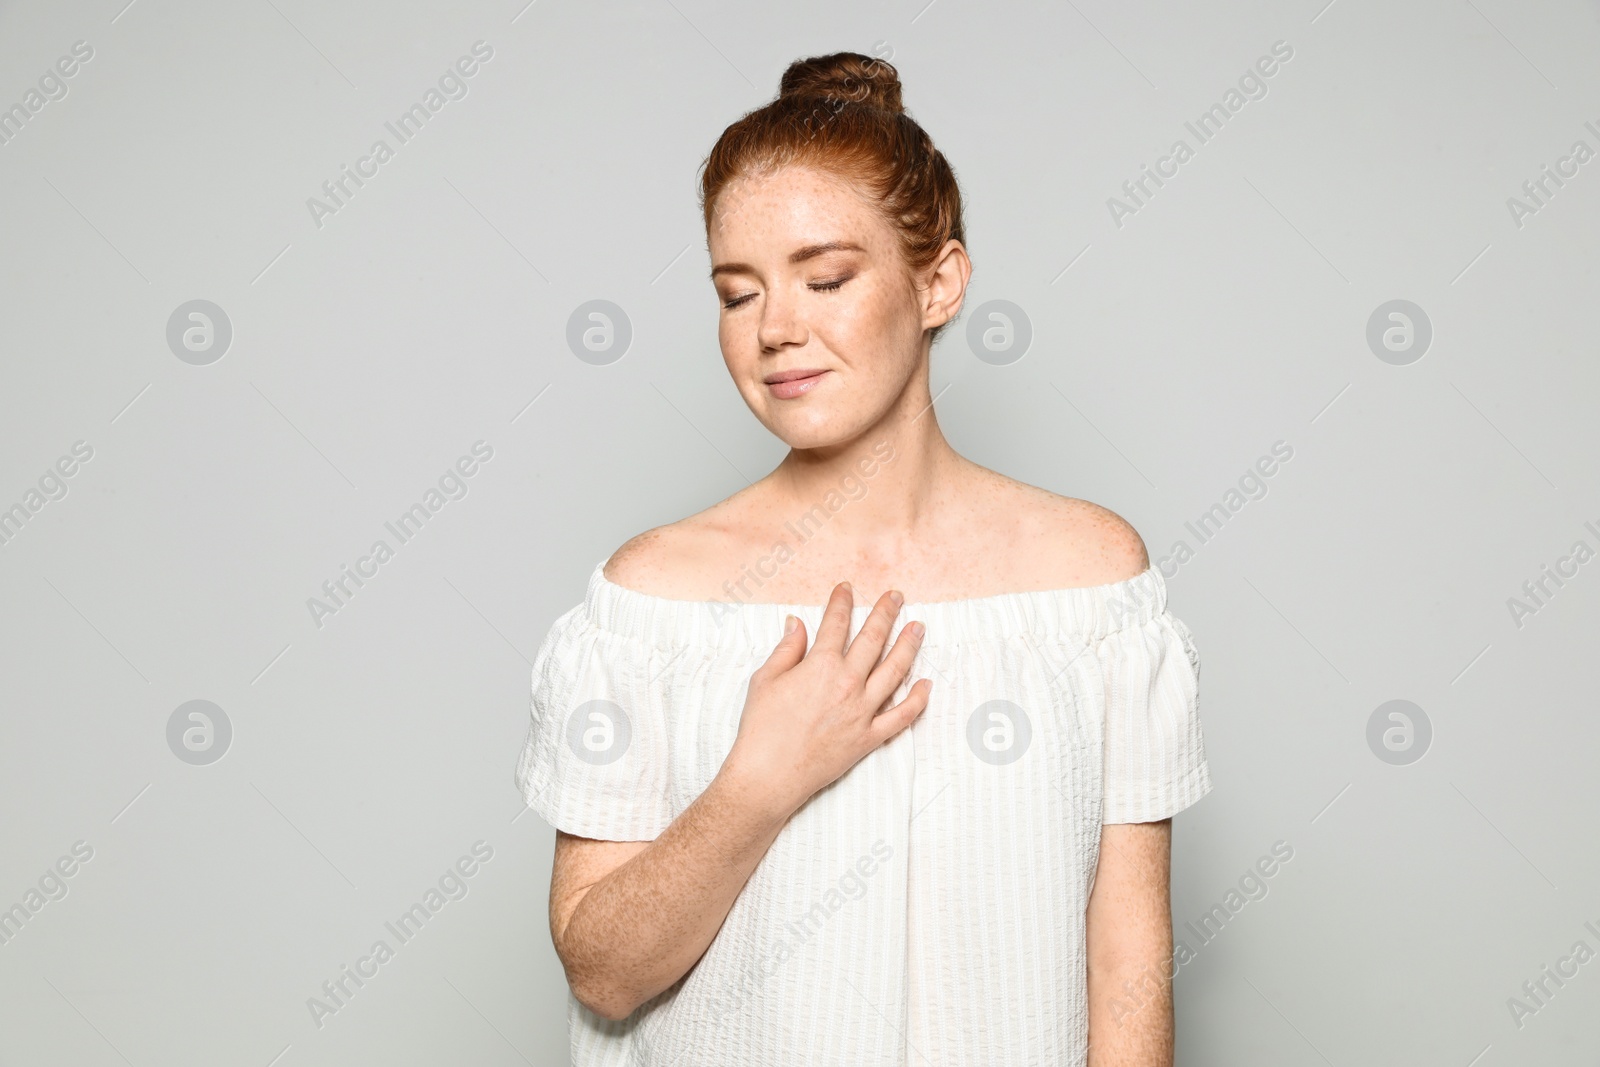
[[582, 558, 1166, 656]]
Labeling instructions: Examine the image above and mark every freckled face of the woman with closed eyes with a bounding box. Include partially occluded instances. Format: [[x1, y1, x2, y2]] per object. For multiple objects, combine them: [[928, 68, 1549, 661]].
[[709, 165, 949, 448]]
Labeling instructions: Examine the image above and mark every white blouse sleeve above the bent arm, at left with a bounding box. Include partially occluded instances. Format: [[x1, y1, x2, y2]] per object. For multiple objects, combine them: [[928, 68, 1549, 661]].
[[517, 605, 672, 841]]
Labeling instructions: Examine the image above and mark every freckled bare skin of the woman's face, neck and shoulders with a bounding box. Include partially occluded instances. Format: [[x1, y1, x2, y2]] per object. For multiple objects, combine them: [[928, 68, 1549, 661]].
[[605, 166, 1149, 603]]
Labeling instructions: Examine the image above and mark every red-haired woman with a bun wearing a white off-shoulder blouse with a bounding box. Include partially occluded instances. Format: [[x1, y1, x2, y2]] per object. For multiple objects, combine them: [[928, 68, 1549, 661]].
[[517, 53, 1211, 1067]]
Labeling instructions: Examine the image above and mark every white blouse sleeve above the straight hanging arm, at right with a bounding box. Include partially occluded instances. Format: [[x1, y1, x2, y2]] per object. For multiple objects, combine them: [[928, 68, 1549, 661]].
[[1099, 609, 1211, 822]]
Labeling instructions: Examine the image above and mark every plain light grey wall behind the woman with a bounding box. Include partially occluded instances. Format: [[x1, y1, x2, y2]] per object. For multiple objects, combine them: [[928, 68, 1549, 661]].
[[0, 0, 1600, 1067]]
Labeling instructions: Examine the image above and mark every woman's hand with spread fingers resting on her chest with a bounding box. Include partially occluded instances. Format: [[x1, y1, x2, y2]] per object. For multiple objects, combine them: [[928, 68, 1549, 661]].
[[723, 582, 933, 814]]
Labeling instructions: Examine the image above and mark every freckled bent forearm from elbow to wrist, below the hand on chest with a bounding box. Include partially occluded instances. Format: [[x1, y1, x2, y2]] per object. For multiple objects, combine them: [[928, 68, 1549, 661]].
[[557, 761, 795, 1019]]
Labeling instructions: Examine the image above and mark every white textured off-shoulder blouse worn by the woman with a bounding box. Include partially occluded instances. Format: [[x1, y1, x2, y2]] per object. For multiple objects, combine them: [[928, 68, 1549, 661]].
[[517, 561, 1211, 1067]]
